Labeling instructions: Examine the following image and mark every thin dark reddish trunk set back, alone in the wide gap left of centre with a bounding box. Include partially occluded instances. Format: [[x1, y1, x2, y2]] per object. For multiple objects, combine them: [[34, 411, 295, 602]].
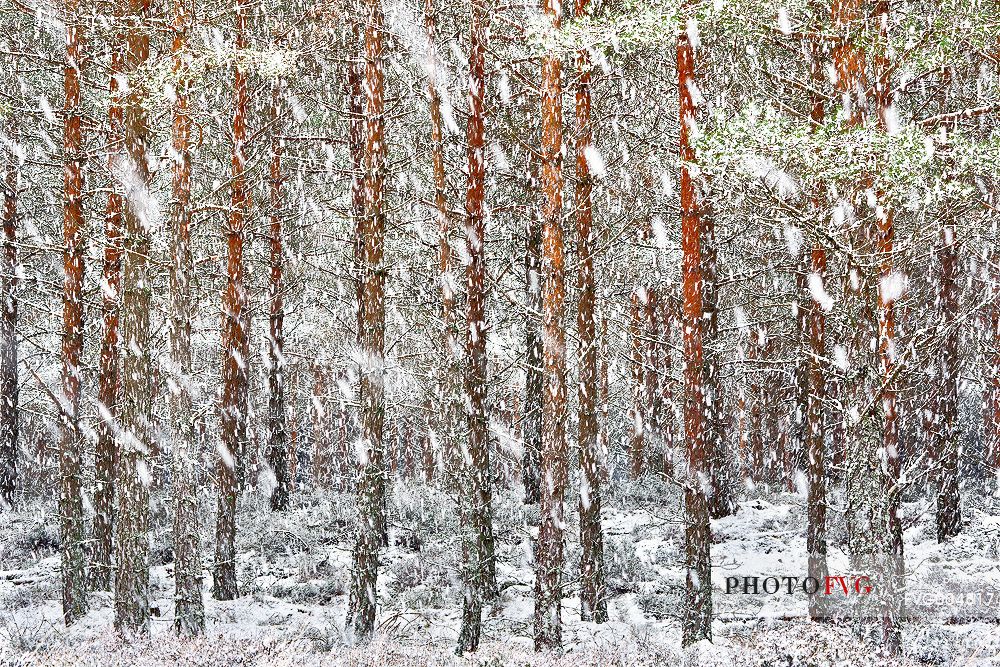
[[267, 78, 289, 511]]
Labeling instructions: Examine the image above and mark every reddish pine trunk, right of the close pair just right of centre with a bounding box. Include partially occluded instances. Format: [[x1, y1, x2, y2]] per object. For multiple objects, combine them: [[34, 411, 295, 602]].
[[575, 0, 608, 623]]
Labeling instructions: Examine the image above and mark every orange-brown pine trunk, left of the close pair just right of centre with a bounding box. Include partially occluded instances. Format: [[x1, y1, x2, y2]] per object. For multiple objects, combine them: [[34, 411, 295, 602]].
[[535, 0, 569, 651]]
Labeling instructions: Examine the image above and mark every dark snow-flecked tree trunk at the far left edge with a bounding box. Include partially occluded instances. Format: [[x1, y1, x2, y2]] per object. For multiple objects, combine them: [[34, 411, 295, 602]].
[[0, 121, 19, 510]]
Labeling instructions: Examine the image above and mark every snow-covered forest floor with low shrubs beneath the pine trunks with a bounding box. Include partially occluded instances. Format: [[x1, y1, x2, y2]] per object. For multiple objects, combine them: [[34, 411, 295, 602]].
[[0, 479, 1000, 667]]
